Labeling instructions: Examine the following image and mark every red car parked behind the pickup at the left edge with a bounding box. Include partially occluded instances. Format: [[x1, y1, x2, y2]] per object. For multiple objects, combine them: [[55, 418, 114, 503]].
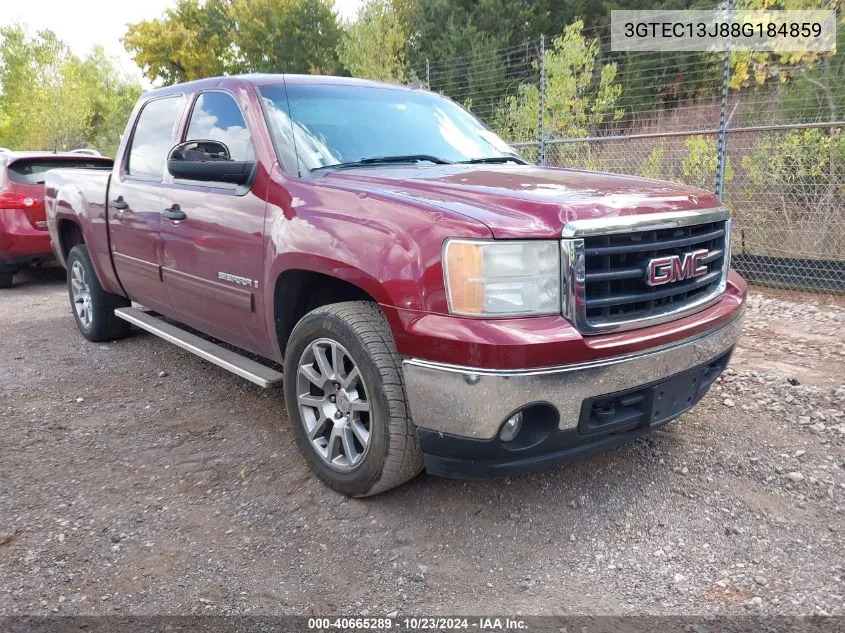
[[0, 149, 114, 288]]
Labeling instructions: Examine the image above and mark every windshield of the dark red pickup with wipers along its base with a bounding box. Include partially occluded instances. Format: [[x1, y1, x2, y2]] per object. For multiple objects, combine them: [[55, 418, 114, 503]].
[[260, 84, 515, 173]]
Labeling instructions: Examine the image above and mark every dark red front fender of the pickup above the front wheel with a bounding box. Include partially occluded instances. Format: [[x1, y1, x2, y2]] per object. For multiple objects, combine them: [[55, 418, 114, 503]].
[[264, 170, 492, 360]]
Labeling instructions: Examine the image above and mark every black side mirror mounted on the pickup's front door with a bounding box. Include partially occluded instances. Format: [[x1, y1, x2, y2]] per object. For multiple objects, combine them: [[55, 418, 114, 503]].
[[167, 140, 255, 185]]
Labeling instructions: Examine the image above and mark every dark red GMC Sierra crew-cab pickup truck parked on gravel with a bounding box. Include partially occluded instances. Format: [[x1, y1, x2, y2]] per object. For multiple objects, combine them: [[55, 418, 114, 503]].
[[47, 75, 746, 496]]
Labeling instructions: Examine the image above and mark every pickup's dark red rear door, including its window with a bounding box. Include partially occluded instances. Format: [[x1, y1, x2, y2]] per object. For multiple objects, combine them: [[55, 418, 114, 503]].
[[108, 95, 184, 313]]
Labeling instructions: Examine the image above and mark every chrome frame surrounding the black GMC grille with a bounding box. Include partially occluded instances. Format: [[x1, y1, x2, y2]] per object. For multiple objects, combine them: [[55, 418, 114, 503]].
[[561, 208, 731, 335]]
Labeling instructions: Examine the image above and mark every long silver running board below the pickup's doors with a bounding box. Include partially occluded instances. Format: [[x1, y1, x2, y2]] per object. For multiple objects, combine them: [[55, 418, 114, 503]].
[[114, 308, 282, 389]]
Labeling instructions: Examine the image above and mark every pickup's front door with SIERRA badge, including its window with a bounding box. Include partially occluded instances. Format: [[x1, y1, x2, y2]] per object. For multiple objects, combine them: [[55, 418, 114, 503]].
[[161, 91, 266, 353]]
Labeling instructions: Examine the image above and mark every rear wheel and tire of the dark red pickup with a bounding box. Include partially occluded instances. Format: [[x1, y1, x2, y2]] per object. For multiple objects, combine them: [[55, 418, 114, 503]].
[[67, 244, 131, 343]]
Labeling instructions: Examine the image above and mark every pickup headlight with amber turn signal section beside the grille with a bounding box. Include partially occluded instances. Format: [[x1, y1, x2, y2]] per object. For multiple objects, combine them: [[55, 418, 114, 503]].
[[443, 240, 560, 316]]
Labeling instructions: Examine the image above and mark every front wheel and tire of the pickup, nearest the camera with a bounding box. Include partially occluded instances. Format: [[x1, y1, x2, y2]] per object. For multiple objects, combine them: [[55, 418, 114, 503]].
[[284, 301, 423, 497]]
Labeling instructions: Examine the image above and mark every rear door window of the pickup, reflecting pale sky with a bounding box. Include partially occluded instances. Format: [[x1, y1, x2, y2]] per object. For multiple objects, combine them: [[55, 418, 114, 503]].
[[126, 95, 182, 180]]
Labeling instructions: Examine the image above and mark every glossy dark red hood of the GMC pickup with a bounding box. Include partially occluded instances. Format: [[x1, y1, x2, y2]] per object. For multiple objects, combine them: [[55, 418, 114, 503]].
[[325, 165, 721, 238]]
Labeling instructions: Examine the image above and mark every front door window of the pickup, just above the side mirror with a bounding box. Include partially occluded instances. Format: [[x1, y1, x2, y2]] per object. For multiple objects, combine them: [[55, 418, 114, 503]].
[[190, 92, 255, 162]]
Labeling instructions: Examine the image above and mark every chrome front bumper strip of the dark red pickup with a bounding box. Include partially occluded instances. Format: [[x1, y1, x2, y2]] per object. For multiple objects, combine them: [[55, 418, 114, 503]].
[[403, 313, 742, 439]]
